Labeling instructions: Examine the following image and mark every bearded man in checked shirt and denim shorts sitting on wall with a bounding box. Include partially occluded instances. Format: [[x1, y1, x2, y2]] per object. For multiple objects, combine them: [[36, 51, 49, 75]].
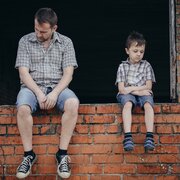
[[15, 8, 79, 179]]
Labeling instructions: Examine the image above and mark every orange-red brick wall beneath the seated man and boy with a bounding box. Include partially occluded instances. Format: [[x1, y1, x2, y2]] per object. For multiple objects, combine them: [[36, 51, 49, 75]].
[[0, 104, 180, 180]]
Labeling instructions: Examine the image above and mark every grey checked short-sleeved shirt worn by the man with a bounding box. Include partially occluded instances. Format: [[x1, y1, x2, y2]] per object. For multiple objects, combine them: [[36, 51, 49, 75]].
[[15, 32, 78, 90]]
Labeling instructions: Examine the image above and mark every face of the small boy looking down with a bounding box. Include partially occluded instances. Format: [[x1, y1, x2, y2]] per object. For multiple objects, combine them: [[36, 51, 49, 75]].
[[125, 42, 145, 63]]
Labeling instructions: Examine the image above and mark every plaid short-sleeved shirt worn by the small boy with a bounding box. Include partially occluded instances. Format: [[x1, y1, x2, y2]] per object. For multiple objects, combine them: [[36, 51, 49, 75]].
[[116, 60, 156, 87]]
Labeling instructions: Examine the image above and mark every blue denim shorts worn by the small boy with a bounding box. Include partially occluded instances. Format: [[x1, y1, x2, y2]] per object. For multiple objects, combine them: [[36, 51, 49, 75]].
[[116, 94, 154, 108]]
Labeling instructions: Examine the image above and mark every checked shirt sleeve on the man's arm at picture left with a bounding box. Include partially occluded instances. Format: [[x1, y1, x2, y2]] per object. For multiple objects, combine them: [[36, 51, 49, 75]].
[[15, 38, 30, 68]]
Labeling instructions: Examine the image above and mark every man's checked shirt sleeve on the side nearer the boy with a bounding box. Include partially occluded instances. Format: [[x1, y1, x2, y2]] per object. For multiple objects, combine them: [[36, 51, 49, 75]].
[[62, 38, 78, 69]]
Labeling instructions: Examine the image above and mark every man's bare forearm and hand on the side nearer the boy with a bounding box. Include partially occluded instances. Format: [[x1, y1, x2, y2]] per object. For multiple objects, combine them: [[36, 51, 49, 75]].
[[45, 66, 74, 109]]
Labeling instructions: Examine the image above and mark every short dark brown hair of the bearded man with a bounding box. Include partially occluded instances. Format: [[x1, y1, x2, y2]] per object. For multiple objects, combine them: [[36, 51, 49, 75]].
[[34, 8, 58, 27]]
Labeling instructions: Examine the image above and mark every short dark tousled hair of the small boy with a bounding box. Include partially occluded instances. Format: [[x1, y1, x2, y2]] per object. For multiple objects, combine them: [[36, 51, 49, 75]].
[[125, 31, 146, 49]]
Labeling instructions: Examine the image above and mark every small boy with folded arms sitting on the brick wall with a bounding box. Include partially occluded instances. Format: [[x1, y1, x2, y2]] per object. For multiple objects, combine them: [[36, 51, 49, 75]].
[[116, 32, 155, 151]]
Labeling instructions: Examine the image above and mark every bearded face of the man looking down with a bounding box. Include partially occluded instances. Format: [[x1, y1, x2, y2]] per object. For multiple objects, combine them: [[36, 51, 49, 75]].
[[34, 19, 57, 42]]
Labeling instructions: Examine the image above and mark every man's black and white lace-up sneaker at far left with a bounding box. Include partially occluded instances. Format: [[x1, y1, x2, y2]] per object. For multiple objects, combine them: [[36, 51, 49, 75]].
[[16, 155, 37, 179]]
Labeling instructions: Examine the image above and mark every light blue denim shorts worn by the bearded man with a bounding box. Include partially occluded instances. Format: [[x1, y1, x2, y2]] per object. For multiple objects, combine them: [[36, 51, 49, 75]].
[[16, 87, 78, 113]]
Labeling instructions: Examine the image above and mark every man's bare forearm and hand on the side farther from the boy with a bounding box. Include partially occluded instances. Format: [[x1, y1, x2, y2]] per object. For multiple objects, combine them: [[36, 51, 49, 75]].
[[19, 67, 46, 109]]
